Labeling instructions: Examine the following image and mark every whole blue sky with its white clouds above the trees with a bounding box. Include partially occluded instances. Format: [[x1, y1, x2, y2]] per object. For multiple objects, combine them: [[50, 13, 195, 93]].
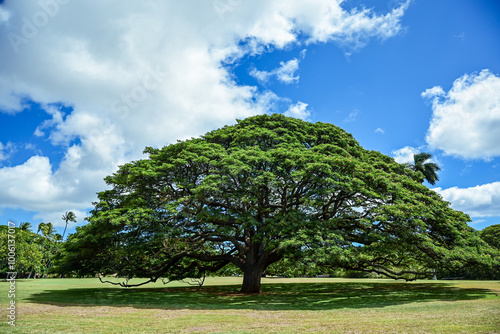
[[0, 0, 500, 236]]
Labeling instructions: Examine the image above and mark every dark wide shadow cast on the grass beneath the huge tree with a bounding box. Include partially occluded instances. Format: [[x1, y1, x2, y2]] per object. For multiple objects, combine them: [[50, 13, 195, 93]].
[[28, 282, 494, 310]]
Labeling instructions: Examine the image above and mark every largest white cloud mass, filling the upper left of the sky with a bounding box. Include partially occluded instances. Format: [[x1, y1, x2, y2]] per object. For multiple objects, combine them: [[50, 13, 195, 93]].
[[0, 0, 409, 224]]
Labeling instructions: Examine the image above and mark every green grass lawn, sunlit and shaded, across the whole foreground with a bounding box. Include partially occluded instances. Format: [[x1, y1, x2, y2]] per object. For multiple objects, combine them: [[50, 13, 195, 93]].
[[0, 277, 500, 333]]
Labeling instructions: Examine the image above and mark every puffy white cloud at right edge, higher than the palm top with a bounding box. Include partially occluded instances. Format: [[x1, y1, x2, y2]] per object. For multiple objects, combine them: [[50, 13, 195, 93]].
[[422, 70, 500, 160]]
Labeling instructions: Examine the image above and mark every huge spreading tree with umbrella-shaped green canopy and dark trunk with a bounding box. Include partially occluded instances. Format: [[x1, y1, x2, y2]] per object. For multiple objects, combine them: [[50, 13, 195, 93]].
[[66, 114, 495, 293]]
